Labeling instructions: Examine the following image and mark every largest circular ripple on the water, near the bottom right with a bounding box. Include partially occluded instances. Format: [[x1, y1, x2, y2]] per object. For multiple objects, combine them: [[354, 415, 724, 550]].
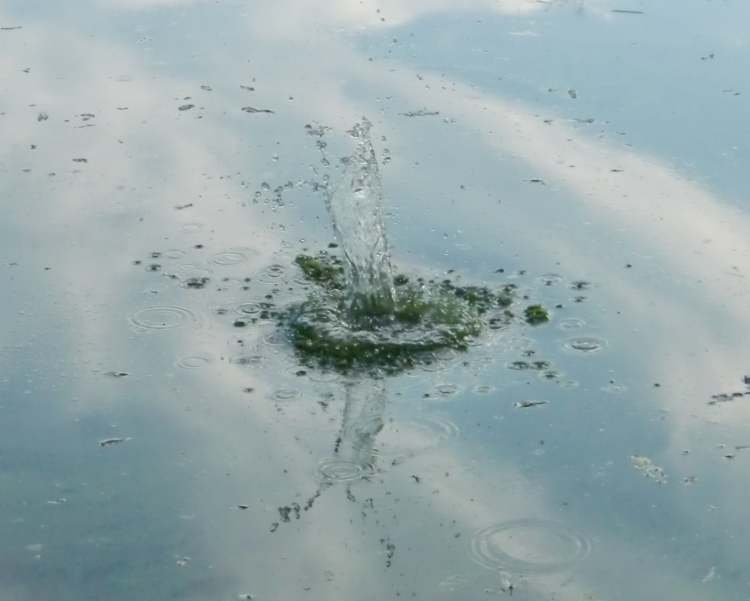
[[471, 519, 591, 574]]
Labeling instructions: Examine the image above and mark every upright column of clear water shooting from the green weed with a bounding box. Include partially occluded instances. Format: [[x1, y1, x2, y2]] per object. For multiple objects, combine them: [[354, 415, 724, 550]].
[[327, 117, 396, 321]]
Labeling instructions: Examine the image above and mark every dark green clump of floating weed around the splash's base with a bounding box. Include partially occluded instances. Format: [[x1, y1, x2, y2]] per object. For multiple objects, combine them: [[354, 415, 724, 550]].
[[282, 251, 514, 372]]
